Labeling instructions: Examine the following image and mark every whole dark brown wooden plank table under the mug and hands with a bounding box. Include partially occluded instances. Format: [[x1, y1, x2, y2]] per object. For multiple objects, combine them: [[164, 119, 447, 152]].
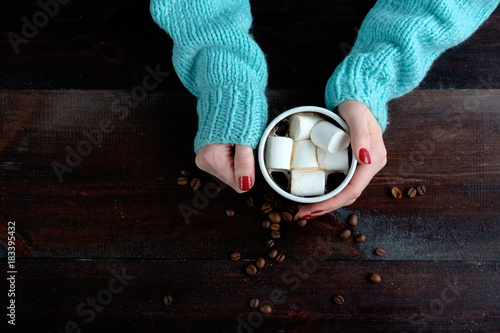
[[0, 0, 500, 332]]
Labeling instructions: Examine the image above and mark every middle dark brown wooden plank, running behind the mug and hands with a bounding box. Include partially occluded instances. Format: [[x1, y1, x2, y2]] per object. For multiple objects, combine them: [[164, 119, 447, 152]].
[[0, 90, 500, 261]]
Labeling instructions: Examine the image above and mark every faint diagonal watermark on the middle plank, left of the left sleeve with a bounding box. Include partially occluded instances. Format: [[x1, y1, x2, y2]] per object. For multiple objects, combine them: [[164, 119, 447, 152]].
[[51, 64, 170, 182]]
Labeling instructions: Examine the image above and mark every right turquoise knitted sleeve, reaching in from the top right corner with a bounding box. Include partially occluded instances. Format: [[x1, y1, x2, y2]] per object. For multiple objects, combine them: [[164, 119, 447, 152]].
[[325, 0, 499, 130]]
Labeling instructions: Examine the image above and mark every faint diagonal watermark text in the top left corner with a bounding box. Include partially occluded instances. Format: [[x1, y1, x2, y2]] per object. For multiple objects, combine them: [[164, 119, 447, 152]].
[[7, 0, 70, 54]]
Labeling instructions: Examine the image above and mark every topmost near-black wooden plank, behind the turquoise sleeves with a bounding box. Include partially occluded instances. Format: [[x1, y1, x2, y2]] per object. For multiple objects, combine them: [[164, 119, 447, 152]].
[[0, 0, 500, 91]]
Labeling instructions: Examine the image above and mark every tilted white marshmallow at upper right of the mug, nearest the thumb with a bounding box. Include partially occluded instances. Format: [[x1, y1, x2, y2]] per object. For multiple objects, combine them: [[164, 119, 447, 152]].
[[311, 121, 351, 154]]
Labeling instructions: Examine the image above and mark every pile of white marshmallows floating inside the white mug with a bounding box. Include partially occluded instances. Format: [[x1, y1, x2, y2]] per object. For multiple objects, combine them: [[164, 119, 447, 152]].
[[265, 112, 350, 197]]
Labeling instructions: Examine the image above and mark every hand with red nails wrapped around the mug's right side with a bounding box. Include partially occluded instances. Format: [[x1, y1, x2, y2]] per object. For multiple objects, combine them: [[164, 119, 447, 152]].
[[298, 101, 387, 219]]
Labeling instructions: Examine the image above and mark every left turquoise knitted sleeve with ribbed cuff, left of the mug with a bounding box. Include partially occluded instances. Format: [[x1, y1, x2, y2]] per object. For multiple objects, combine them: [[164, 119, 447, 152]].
[[150, 0, 267, 152]]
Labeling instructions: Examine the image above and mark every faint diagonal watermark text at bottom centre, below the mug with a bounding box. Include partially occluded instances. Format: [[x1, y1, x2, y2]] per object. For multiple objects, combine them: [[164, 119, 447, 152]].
[[236, 236, 333, 333]]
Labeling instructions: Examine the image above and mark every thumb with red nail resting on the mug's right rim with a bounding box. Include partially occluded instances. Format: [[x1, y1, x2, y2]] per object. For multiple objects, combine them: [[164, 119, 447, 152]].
[[339, 101, 371, 164]]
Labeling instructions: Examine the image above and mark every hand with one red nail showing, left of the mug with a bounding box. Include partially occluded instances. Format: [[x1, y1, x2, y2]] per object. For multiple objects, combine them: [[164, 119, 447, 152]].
[[195, 143, 255, 193]]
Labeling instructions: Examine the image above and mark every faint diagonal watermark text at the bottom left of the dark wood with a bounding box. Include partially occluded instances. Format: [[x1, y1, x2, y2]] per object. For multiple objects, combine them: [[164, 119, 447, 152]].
[[61, 268, 135, 333]]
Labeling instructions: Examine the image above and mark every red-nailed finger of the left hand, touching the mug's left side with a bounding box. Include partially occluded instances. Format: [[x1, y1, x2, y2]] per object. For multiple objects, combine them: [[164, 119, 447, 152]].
[[234, 145, 255, 192]]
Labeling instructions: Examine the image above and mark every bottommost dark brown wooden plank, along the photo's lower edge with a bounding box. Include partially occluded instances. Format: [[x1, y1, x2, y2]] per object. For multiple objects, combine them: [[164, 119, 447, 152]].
[[0, 260, 500, 332]]
